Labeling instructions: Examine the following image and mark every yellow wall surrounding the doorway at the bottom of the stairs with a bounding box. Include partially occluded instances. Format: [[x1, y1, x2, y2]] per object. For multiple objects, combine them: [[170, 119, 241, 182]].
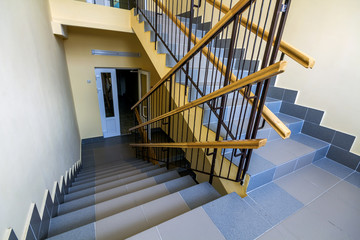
[[64, 28, 160, 139]]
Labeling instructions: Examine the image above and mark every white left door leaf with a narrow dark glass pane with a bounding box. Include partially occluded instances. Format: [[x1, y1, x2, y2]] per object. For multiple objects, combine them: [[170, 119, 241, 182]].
[[95, 68, 120, 138]]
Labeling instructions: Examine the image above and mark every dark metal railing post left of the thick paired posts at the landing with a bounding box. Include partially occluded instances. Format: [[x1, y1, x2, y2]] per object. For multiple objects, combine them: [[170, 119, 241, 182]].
[[209, 14, 239, 184]]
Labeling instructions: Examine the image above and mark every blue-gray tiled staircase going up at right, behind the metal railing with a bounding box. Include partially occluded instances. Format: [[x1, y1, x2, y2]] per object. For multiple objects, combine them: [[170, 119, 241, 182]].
[[131, 6, 330, 191]]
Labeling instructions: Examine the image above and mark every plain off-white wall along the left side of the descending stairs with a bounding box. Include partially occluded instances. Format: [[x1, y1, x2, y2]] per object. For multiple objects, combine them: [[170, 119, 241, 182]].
[[0, 0, 80, 238]]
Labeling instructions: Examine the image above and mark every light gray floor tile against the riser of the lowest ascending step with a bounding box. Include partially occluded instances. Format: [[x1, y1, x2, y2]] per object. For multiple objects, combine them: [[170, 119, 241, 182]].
[[275, 164, 340, 204]]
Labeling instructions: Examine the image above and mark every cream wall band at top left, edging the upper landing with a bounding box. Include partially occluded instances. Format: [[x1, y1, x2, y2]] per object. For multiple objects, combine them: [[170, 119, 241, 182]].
[[49, 0, 132, 32]]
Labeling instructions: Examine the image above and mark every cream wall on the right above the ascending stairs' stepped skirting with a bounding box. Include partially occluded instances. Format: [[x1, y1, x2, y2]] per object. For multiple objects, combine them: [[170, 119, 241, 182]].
[[277, 0, 360, 154]]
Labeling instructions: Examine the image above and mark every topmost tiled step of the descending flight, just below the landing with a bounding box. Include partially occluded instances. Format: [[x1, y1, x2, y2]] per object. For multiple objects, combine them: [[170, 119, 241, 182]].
[[49, 183, 220, 239]]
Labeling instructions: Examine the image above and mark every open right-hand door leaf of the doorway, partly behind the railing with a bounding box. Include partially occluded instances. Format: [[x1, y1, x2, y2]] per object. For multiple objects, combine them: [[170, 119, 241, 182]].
[[138, 70, 151, 139]]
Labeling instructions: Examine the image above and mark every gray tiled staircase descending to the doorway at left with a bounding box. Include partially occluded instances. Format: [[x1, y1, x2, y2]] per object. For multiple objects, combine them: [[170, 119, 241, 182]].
[[48, 137, 231, 239]]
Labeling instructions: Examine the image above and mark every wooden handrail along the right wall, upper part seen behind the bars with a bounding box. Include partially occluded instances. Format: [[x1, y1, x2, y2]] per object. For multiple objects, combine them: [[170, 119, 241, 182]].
[[206, 0, 315, 68]]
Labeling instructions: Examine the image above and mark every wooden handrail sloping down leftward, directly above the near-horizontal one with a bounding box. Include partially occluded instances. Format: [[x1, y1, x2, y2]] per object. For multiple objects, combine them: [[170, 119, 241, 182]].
[[129, 61, 287, 131]]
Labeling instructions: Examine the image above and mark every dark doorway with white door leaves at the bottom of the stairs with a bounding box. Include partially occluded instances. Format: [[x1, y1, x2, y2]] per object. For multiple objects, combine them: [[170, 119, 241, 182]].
[[95, 68, 150, 138]]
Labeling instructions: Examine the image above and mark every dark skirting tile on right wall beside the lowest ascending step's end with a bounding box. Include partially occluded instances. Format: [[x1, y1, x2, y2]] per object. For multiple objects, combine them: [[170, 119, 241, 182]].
[[326, 145, 360, 170]]
